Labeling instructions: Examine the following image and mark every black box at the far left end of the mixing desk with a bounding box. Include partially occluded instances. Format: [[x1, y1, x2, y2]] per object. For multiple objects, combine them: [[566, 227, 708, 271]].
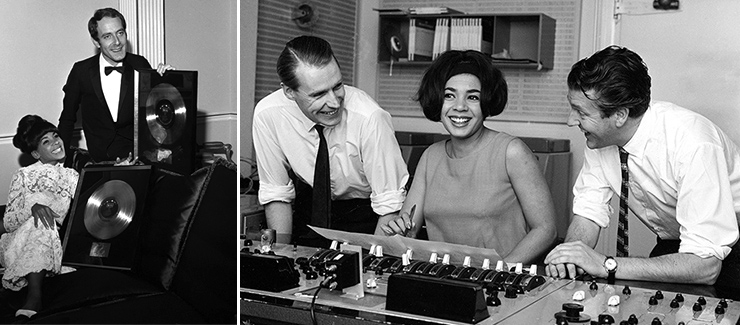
[[240, 249, 300, 292]]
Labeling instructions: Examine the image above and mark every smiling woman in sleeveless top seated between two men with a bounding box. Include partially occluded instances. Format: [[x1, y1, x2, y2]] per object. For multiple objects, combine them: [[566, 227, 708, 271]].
[[380, 51, 556, 263]]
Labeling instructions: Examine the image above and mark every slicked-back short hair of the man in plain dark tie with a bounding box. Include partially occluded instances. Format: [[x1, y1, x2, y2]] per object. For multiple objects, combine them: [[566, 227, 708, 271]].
[[277, 36, 339, 89]]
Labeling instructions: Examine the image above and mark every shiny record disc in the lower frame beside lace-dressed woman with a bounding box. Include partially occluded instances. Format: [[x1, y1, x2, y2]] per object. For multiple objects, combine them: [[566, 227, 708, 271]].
[[85, 179, 136, 240]]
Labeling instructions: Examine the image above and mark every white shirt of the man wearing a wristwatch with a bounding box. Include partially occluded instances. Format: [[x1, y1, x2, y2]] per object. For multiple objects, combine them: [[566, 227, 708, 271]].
[[573, 102, 740, 259]]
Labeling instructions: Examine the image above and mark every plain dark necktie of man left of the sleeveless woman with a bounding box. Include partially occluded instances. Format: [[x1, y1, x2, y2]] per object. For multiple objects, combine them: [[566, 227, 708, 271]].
[[311, 124, 331, 228]]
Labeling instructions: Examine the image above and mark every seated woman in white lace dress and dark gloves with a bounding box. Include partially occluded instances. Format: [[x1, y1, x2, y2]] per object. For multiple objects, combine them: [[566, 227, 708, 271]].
[[0, 115, 78, 318]]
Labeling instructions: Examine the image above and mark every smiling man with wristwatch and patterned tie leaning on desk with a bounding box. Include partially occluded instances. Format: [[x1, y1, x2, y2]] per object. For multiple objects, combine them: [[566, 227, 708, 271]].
[[545, 46, 740, 288]]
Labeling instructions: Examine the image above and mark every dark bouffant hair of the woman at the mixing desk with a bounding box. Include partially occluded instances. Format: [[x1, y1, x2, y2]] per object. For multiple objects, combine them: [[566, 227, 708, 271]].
[[416, 50, 508, 122]]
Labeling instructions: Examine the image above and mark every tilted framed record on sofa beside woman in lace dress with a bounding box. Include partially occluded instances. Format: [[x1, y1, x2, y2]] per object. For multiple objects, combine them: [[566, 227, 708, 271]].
[[62, 166, 151, 270]]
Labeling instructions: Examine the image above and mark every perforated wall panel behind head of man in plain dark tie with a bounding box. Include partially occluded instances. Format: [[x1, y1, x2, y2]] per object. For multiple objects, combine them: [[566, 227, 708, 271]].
[[256, 0, 356, 101]]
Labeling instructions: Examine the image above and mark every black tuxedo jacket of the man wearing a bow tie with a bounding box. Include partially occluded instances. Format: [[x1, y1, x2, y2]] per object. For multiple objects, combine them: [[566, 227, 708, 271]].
[[58, 53, 152, 166]]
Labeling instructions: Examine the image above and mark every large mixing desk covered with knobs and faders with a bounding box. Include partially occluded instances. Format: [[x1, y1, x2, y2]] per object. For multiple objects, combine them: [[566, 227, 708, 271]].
[[241, 244, 740, 325]]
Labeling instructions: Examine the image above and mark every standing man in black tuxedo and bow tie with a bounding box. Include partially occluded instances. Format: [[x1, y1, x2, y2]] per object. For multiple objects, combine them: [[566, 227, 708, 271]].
[[59, 8, 173, 166]]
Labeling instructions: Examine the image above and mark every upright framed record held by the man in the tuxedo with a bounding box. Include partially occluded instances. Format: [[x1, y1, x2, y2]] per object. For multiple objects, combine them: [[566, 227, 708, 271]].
[[134, 70, 198, 175]]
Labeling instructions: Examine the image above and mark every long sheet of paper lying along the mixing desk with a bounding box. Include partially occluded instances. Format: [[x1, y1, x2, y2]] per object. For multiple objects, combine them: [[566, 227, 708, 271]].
[[309, 226, 506, 268]]
